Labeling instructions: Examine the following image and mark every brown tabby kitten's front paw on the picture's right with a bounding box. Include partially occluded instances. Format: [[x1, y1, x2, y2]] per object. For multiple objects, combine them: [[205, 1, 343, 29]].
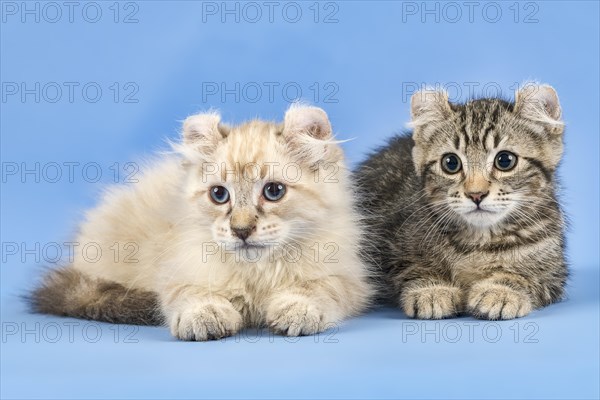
[[467, 282, 533, 320]]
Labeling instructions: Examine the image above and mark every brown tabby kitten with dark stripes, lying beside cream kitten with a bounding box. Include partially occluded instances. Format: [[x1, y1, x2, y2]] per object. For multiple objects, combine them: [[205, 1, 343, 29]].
[[357, 84, 567, 320]]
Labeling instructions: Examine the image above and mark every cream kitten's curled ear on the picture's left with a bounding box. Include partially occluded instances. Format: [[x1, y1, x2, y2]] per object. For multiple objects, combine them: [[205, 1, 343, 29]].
[[178, 111, 229, 160]]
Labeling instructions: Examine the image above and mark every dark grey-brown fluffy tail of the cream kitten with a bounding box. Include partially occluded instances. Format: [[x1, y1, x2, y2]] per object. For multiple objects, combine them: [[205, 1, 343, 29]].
[[28, 268, 163, 325]]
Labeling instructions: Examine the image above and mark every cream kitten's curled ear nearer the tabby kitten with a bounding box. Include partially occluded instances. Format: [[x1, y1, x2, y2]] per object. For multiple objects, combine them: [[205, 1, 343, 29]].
[[282, 104, 341, 164]]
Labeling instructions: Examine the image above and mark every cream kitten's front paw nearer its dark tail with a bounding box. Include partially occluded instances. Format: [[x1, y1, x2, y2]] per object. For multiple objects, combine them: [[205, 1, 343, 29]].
[[170, 299, 243, 341]]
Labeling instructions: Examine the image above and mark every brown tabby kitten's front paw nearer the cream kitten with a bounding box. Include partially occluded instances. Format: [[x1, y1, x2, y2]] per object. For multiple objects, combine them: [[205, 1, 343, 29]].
[[400, 285, 461, 319]]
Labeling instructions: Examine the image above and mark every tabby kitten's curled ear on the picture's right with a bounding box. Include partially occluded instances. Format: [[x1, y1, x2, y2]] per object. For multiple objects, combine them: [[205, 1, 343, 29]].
[[515, 83, 563, 133]]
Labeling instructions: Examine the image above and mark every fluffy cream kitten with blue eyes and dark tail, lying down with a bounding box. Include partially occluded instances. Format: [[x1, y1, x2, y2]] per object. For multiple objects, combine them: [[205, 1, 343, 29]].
[[31, 106, 371, 340]]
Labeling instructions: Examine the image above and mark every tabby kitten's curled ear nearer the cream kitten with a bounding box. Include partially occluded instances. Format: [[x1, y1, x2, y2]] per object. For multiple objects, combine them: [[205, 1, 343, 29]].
[[410, 89, 452, 128]]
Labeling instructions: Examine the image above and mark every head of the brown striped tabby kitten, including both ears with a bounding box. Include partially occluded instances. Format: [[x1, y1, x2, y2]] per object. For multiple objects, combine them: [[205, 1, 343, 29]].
[[411, 84, 563, 227]]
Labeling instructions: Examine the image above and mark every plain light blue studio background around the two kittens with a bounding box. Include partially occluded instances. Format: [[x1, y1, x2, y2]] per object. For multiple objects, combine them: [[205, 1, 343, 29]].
[[0, 1, 600, 398]]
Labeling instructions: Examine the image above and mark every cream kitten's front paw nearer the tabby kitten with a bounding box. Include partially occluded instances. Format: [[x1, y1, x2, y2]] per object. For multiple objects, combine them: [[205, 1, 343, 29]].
[[266, 296, 325, 336]]
